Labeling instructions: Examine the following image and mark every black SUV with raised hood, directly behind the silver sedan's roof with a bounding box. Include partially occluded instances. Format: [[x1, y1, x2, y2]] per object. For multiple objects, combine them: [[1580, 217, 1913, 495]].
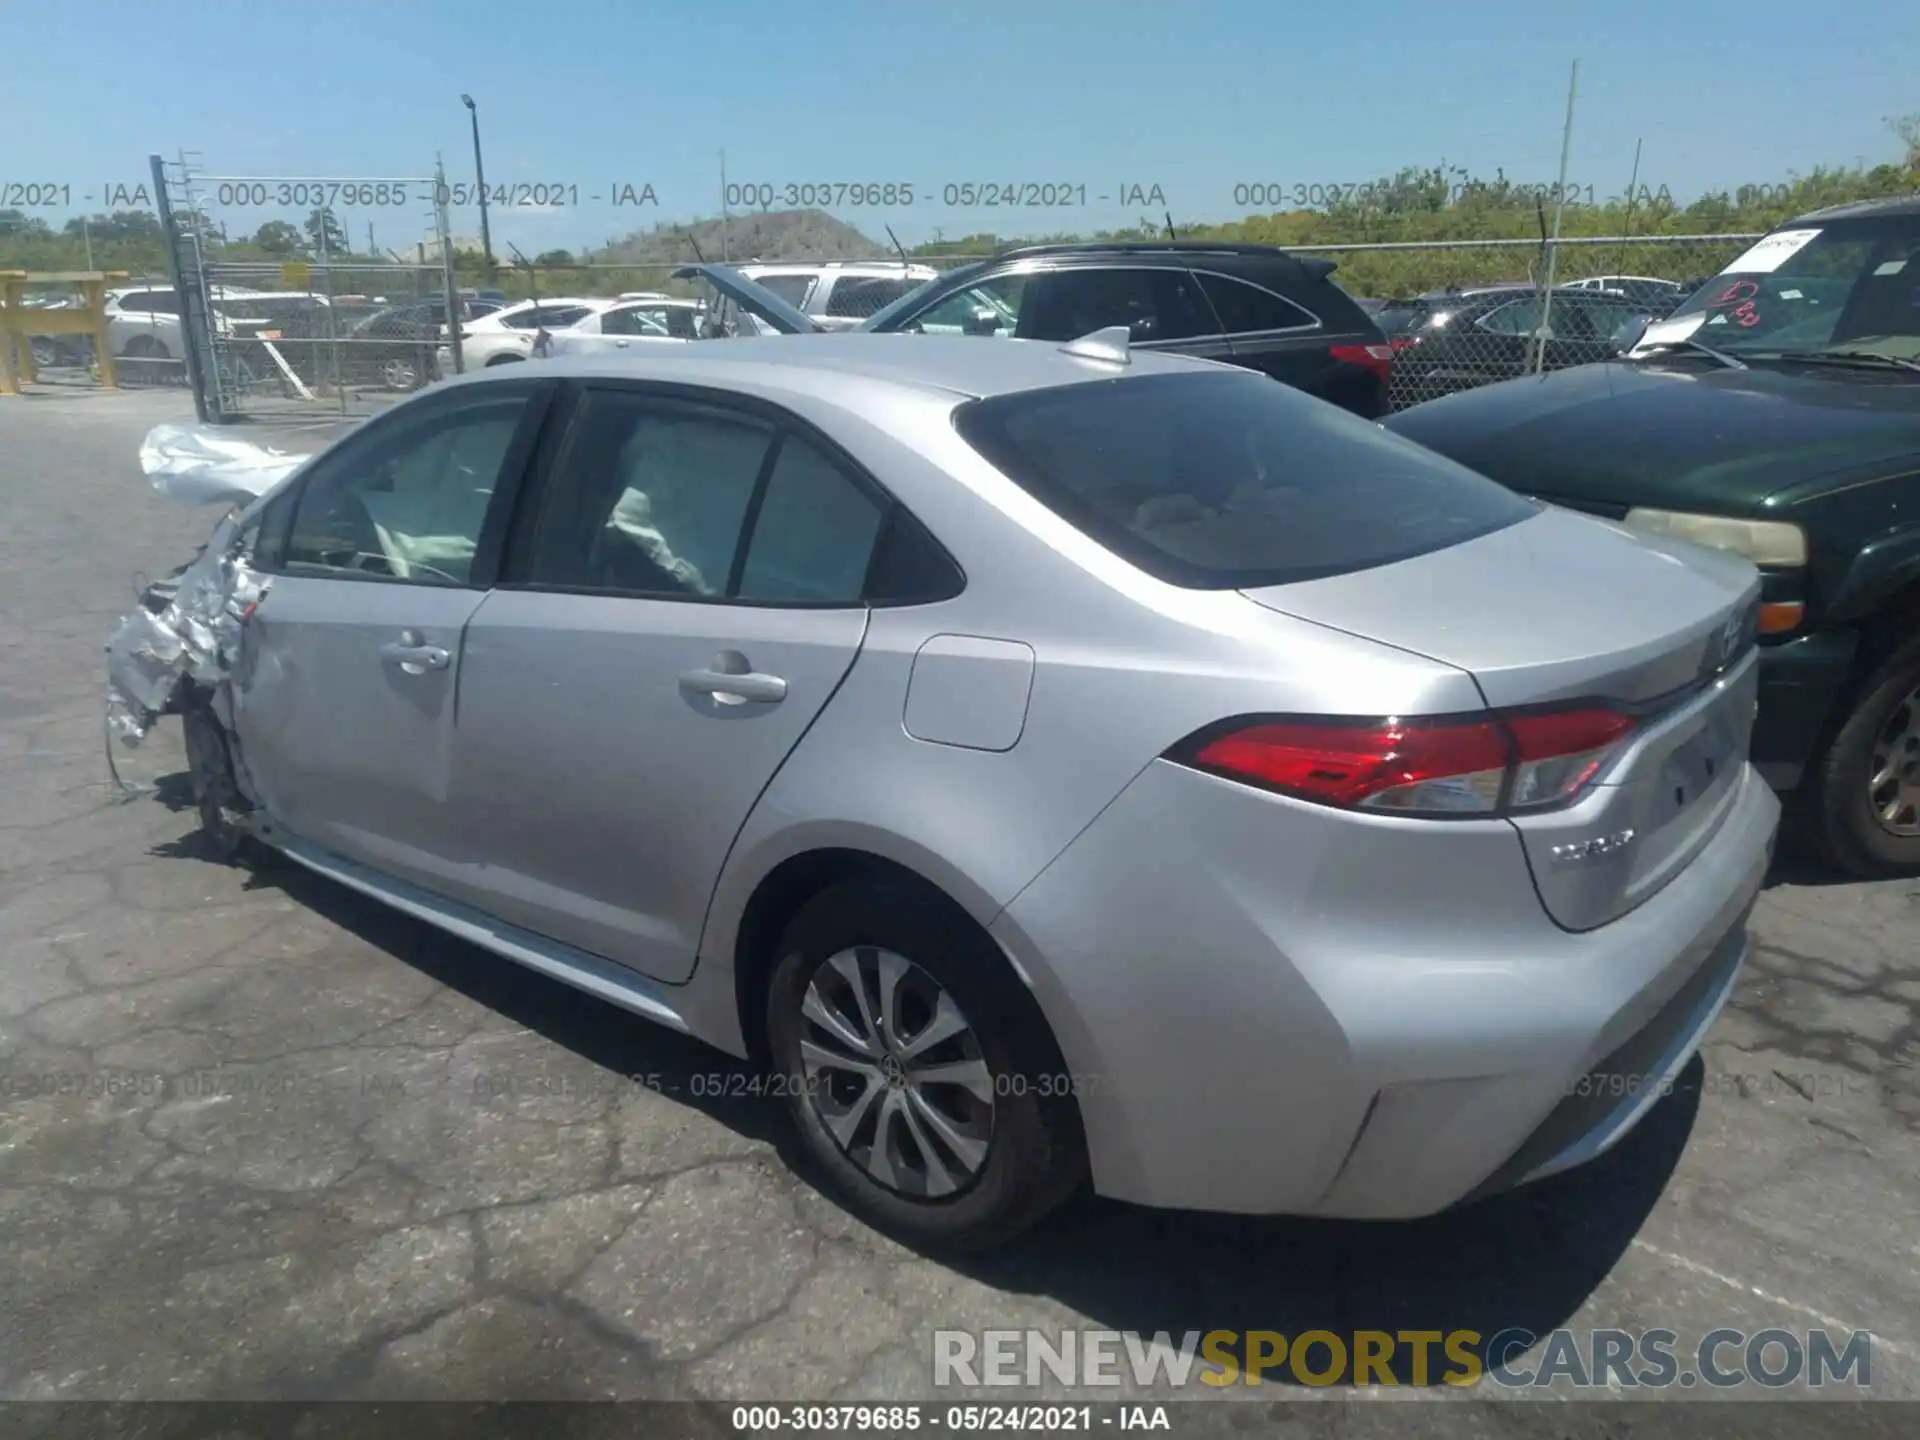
[[680, 242, 1394, 419]]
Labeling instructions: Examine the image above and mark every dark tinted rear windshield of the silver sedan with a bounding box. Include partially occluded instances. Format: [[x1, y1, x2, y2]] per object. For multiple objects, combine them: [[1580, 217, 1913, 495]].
[[954, 371, 1536, 589]]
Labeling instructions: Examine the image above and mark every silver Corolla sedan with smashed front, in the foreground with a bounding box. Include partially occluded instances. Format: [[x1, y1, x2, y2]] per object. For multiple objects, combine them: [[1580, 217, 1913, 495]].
[[165, 332, 1778, 1246]]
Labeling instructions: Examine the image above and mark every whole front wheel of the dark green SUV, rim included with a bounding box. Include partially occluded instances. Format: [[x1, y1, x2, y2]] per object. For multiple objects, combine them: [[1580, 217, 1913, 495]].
[[1809, 639, 1920, 876]]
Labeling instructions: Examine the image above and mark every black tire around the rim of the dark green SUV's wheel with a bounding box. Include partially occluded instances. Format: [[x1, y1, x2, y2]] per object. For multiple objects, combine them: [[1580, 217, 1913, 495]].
[[1803, 637, 1920, 877]]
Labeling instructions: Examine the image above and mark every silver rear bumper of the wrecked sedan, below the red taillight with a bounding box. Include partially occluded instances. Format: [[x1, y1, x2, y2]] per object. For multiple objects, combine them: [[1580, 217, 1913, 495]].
[[993, 762, 1780, 1219]]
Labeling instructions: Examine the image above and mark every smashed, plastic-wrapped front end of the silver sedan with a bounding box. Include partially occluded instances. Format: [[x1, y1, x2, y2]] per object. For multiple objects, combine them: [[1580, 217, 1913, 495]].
[[106, 424, 307, 856]]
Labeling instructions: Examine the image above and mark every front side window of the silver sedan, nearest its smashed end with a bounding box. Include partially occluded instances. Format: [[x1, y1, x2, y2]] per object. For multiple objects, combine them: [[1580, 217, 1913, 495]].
[[284, 395, 532, 586]]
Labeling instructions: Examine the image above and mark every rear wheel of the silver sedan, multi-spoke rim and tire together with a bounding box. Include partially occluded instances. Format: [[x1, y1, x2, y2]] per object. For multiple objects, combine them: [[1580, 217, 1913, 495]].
[[766, 879, 1085, 1250]]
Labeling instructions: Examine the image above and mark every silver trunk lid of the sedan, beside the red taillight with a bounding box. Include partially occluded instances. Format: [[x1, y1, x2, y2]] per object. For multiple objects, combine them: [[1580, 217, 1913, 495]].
[[1246, 509, 1759, 929]]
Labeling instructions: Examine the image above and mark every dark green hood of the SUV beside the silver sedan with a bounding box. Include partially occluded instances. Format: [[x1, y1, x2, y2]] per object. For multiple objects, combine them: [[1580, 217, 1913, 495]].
[[1384, 359, 1920, 513]]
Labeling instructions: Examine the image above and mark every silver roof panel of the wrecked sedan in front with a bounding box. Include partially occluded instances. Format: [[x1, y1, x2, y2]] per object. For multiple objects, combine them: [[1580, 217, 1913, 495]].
[[462, 330, 1242, 399]]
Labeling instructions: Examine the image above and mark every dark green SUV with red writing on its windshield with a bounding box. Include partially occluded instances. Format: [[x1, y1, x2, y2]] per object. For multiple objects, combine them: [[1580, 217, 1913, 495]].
[[1386, 198, 1920, 876]]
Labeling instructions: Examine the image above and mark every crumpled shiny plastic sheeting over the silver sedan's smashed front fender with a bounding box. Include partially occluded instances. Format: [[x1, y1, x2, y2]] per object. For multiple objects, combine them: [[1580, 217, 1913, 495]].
[[108, 515, 267, 745]]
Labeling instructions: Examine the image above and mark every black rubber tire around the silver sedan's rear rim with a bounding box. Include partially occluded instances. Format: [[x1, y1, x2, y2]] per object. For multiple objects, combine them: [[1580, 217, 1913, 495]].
[[766, 879, 1087, 1250]]
